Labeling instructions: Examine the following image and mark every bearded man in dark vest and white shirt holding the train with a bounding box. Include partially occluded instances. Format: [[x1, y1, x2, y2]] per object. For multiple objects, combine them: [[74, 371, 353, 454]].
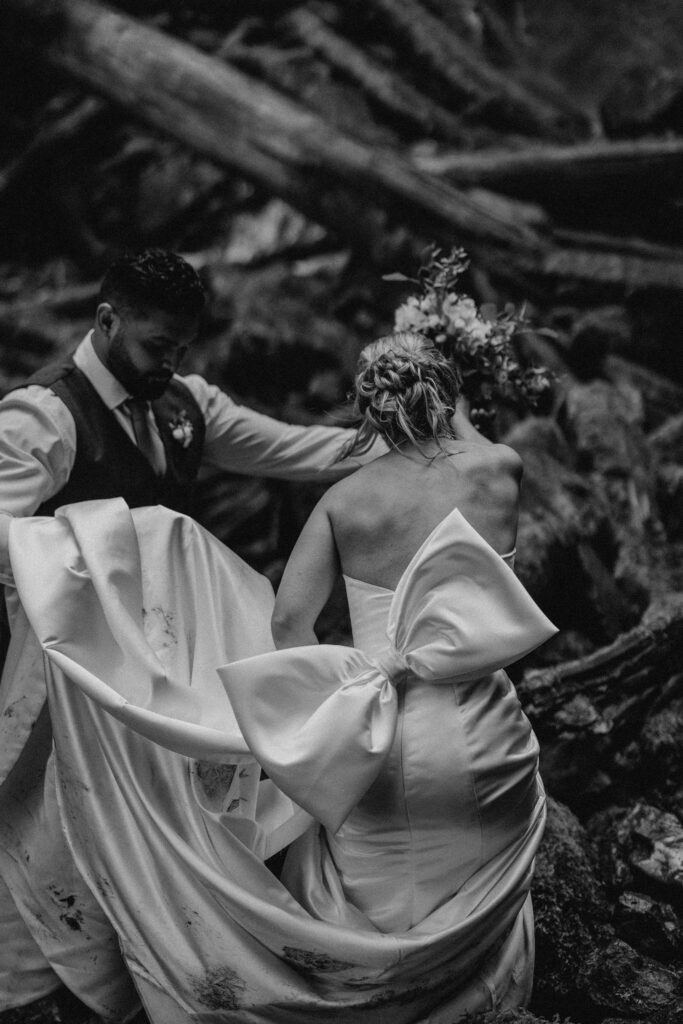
[[0, 250, 374, 551]]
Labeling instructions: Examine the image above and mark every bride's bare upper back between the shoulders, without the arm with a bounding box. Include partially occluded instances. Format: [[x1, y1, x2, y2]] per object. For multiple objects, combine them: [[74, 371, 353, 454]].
[[325, 440, 521, 590]]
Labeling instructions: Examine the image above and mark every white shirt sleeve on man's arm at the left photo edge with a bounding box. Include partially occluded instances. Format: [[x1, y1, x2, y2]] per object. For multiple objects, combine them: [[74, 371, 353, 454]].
[[0, 385, 76, 583]]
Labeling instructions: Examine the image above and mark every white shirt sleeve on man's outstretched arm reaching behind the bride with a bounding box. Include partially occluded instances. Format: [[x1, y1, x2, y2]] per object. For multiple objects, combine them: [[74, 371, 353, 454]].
[[183, 375, 386, 481]]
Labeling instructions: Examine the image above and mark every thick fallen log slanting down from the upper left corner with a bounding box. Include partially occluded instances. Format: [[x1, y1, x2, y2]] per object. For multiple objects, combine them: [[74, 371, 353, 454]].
[[7, 0, 683, 303]]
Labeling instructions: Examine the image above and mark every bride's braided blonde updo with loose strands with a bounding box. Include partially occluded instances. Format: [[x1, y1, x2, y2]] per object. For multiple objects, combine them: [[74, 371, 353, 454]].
[[342, 332, 461, 458]]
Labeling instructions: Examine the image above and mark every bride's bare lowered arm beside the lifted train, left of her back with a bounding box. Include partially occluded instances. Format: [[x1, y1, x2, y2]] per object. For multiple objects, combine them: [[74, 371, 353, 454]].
[[271, 499, 340, 650]]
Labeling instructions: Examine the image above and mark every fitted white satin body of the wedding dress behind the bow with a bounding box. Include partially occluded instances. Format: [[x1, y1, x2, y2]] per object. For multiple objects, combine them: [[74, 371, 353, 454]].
[[317, 579, 542, 932]]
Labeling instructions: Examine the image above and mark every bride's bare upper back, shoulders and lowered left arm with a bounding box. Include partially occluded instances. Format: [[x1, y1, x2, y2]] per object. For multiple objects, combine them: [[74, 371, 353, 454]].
[[272, 441, 521, 647]]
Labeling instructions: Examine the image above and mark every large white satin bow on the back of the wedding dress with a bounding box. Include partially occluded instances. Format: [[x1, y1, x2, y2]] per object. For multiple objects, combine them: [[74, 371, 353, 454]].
[[218, 510, 557, 831]]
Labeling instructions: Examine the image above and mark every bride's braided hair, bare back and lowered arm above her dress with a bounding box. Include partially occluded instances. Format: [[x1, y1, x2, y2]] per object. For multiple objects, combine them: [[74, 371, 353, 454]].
[[272, 333, 521, 647]]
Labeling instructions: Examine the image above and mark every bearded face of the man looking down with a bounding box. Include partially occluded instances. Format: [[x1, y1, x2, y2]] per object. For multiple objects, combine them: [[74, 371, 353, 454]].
[[98, 307, 199, 399]]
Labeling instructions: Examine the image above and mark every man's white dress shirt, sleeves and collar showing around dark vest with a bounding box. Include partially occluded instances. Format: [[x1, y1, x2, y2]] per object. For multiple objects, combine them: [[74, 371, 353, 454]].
[[0, 332, 376, 582]]
